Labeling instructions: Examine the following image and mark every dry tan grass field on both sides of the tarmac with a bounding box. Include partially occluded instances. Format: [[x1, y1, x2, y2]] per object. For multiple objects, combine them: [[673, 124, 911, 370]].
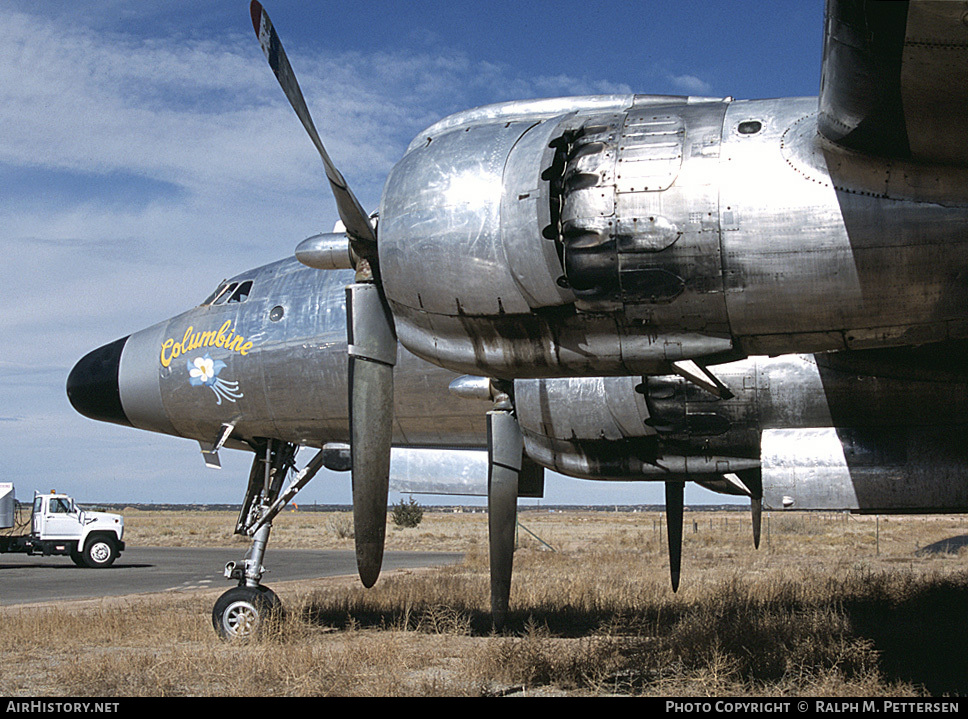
[[0, 512, 968, 697]]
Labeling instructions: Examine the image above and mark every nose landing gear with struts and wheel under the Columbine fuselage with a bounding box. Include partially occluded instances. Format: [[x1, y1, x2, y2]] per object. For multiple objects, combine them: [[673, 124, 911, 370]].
[[212, 439, 323, 640]]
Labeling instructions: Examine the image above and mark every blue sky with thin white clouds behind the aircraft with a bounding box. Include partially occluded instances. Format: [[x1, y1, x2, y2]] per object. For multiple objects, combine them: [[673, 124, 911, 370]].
[[0, 0, 823, 504]]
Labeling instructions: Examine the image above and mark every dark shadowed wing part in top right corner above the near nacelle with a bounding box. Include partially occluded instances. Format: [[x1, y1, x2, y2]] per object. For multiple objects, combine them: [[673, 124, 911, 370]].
[[819, 0, 968, 165]]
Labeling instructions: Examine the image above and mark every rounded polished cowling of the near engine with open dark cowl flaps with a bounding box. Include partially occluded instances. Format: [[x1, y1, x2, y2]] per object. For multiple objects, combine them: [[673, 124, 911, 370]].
[[380, 96, 733, 378]]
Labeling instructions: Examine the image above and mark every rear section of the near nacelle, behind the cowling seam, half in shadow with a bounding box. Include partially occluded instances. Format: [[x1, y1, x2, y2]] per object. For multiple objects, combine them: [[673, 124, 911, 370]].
[[720, 98, 968, 354]]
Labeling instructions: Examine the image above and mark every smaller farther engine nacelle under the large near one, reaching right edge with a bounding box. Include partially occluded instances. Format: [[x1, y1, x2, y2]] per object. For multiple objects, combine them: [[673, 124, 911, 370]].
[[514, 344, 968, 513]]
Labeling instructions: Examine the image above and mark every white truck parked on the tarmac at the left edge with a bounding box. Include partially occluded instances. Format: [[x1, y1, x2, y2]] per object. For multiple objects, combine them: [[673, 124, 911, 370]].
[[0, 482, 124, 569]]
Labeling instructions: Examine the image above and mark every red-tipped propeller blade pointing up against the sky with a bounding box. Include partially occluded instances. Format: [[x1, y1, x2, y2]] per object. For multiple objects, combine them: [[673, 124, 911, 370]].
[[249, 0, 376, 256]]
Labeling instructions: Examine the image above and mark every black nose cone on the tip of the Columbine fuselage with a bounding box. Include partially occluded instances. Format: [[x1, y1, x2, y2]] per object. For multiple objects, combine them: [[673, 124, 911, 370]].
[[67, 337, 132, 427]]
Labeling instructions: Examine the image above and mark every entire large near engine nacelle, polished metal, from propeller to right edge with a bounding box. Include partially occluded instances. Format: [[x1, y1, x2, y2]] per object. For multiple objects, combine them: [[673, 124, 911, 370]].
[[379, 90, 968, 379]]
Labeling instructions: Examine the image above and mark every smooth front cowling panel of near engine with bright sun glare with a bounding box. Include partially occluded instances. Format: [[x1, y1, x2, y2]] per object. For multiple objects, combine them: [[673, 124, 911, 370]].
[[380, 122, 534, 316]]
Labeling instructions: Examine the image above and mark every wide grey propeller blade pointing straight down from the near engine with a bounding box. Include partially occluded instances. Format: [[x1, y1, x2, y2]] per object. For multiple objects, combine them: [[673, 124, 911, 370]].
[[346, 282, 397, 587]]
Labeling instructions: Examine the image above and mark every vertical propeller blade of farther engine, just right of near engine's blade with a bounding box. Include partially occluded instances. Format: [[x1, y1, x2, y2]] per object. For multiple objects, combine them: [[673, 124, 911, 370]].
[[487, 401, 524, 631]]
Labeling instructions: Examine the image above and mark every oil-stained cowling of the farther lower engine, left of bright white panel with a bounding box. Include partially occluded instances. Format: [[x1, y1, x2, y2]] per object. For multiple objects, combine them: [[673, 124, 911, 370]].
[[514, 377, 760, 482]]
